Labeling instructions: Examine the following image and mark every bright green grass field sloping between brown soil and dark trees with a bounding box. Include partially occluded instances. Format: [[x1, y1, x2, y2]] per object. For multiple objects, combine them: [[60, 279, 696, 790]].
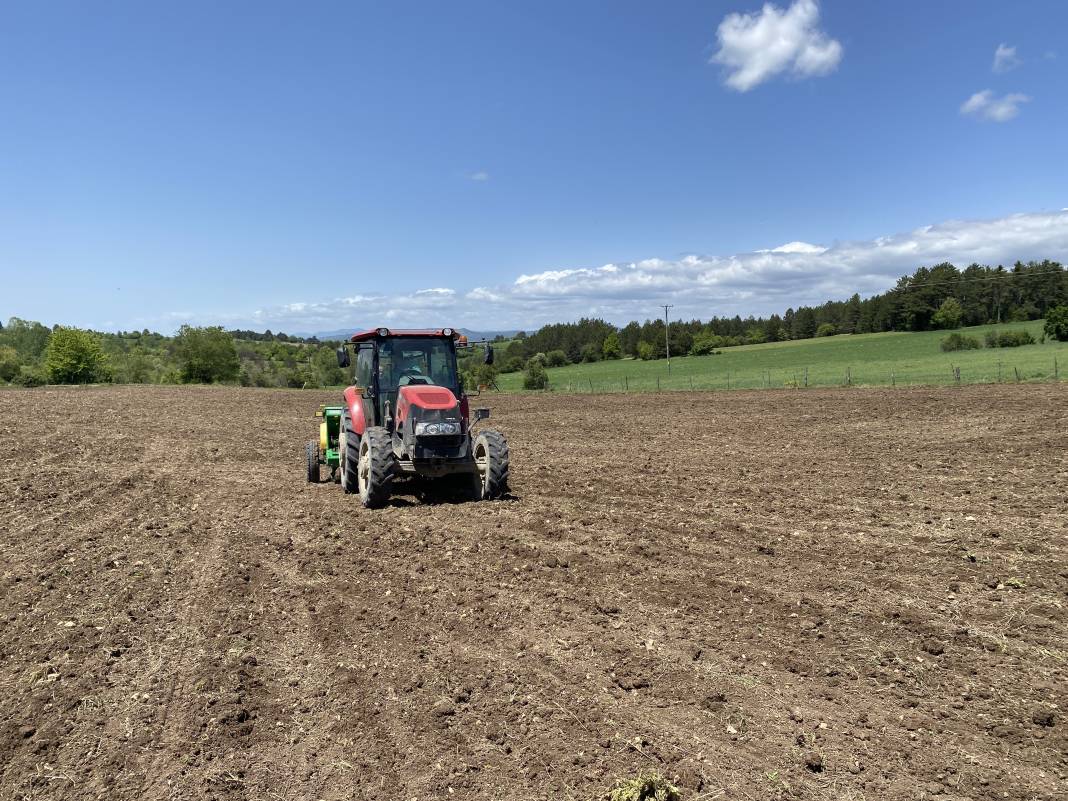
[[498, 320, 1068, 392]]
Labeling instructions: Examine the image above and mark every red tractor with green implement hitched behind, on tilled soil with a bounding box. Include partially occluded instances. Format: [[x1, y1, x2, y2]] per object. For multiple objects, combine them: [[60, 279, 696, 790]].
[[307, 328, 508, 507]]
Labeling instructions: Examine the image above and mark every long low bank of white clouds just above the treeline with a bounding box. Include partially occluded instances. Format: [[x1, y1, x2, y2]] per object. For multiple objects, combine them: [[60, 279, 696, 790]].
[[221, 209, 1068, 331]]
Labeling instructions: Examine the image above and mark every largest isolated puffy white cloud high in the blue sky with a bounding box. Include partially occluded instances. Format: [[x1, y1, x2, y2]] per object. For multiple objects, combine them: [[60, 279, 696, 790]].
[[712, 0, 842, 92]]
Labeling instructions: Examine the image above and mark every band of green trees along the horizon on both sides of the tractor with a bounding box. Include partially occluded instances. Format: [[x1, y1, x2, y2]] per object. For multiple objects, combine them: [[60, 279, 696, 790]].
[[0, 261, 1068, 388]]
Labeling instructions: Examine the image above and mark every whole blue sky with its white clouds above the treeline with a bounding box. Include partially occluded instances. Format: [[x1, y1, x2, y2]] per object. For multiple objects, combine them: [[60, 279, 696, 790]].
[[0, 0, 1068, 331]]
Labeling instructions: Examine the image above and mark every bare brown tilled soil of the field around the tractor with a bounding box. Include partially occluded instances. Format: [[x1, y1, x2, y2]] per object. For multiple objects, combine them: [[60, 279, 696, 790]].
[[0, 386, 1068, 800]]
